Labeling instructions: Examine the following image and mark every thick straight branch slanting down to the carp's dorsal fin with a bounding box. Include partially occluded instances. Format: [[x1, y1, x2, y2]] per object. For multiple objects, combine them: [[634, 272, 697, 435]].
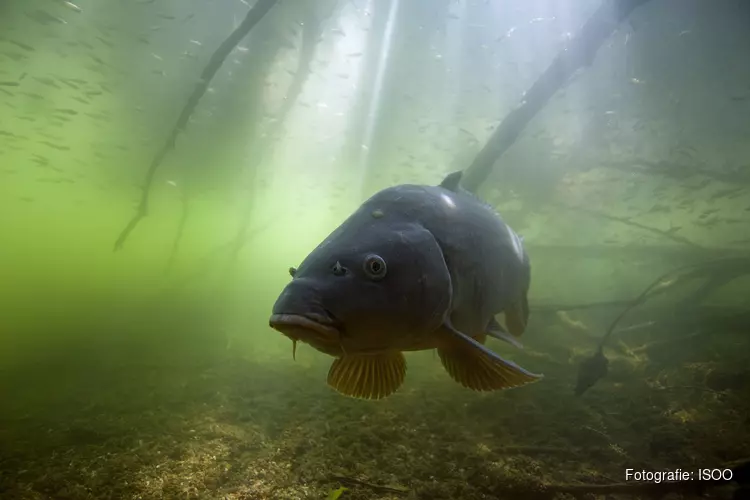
[[462, 0, 648, 193]]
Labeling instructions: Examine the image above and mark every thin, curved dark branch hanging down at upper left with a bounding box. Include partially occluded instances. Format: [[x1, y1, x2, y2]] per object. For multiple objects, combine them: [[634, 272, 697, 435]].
[[114, 0, 278, 251]]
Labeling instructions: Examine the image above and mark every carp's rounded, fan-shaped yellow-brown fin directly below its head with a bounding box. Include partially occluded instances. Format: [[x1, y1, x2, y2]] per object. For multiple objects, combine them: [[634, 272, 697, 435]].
[[328, 351, 406, 399]]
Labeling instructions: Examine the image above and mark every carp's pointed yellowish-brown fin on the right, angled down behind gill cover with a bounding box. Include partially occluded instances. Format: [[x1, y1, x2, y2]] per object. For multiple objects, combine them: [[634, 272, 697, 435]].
[[438, 325, 542, 391]]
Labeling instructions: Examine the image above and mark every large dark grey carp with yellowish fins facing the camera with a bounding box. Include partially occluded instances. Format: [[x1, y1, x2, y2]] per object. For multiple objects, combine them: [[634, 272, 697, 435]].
[[269, 171, 543, 399]]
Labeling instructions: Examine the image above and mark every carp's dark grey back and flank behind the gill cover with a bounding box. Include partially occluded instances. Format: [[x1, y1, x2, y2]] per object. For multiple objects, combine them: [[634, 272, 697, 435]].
[[350, 185, 531, 342]]
